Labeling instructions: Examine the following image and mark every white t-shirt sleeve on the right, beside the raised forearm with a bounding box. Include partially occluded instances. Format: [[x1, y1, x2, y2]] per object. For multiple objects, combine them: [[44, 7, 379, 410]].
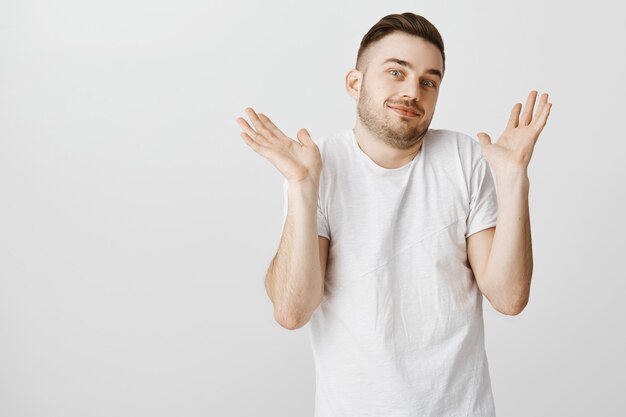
[[465, 157, 498, 237]]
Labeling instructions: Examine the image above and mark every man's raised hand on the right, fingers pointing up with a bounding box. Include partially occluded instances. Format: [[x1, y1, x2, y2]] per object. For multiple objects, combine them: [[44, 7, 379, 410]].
[[477, 90, 552, 176]]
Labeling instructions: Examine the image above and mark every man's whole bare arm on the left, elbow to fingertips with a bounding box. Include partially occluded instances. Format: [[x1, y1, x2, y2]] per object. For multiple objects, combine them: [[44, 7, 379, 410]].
[[237, 107, 329, 329]]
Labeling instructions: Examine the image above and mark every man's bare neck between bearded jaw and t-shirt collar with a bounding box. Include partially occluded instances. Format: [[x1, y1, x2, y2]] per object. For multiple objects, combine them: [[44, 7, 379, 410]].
[[353, 121, 423, 169]]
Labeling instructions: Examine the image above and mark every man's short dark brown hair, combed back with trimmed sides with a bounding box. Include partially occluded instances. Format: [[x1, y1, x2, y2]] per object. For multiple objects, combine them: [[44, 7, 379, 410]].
[[356, 12, 446, 72]]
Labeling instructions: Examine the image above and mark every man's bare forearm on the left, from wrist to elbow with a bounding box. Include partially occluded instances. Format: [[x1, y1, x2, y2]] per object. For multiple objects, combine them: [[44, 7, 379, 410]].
[[266, 182, 324, 328]]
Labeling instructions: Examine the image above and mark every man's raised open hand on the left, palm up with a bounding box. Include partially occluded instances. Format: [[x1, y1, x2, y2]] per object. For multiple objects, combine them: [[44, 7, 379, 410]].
[[237, 107, 322, 183]]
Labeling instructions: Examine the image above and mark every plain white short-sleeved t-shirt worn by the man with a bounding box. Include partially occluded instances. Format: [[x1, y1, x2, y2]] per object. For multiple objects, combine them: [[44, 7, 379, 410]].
[[283, 129, 497, 417]]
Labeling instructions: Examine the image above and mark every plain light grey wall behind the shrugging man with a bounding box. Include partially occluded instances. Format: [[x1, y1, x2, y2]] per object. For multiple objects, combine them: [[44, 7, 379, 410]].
[[0, 0, 626, 417]]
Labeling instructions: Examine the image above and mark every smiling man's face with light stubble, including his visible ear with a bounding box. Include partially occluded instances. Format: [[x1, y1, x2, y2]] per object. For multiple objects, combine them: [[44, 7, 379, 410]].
[[348, 33, 443, 149]]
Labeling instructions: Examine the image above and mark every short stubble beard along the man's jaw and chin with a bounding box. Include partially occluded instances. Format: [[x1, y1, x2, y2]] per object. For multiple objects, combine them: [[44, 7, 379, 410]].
[[357, 84, 432, 149]]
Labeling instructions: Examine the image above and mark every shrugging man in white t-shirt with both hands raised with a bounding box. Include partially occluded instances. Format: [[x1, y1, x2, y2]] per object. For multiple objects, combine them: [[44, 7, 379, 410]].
[[237, 13, 552, 417]]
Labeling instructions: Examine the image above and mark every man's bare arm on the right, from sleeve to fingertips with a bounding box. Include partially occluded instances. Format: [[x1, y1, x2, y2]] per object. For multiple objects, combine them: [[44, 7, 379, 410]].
[[467, 91, 552, 315]]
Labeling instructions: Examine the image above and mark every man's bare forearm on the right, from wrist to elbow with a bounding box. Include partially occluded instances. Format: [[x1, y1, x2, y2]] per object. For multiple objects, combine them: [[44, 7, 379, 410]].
[[485, 170, 533, 314]]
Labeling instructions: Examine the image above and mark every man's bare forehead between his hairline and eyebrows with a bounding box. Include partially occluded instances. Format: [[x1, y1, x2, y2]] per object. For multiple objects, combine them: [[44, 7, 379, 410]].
[[369, 32, 443, 71]]
